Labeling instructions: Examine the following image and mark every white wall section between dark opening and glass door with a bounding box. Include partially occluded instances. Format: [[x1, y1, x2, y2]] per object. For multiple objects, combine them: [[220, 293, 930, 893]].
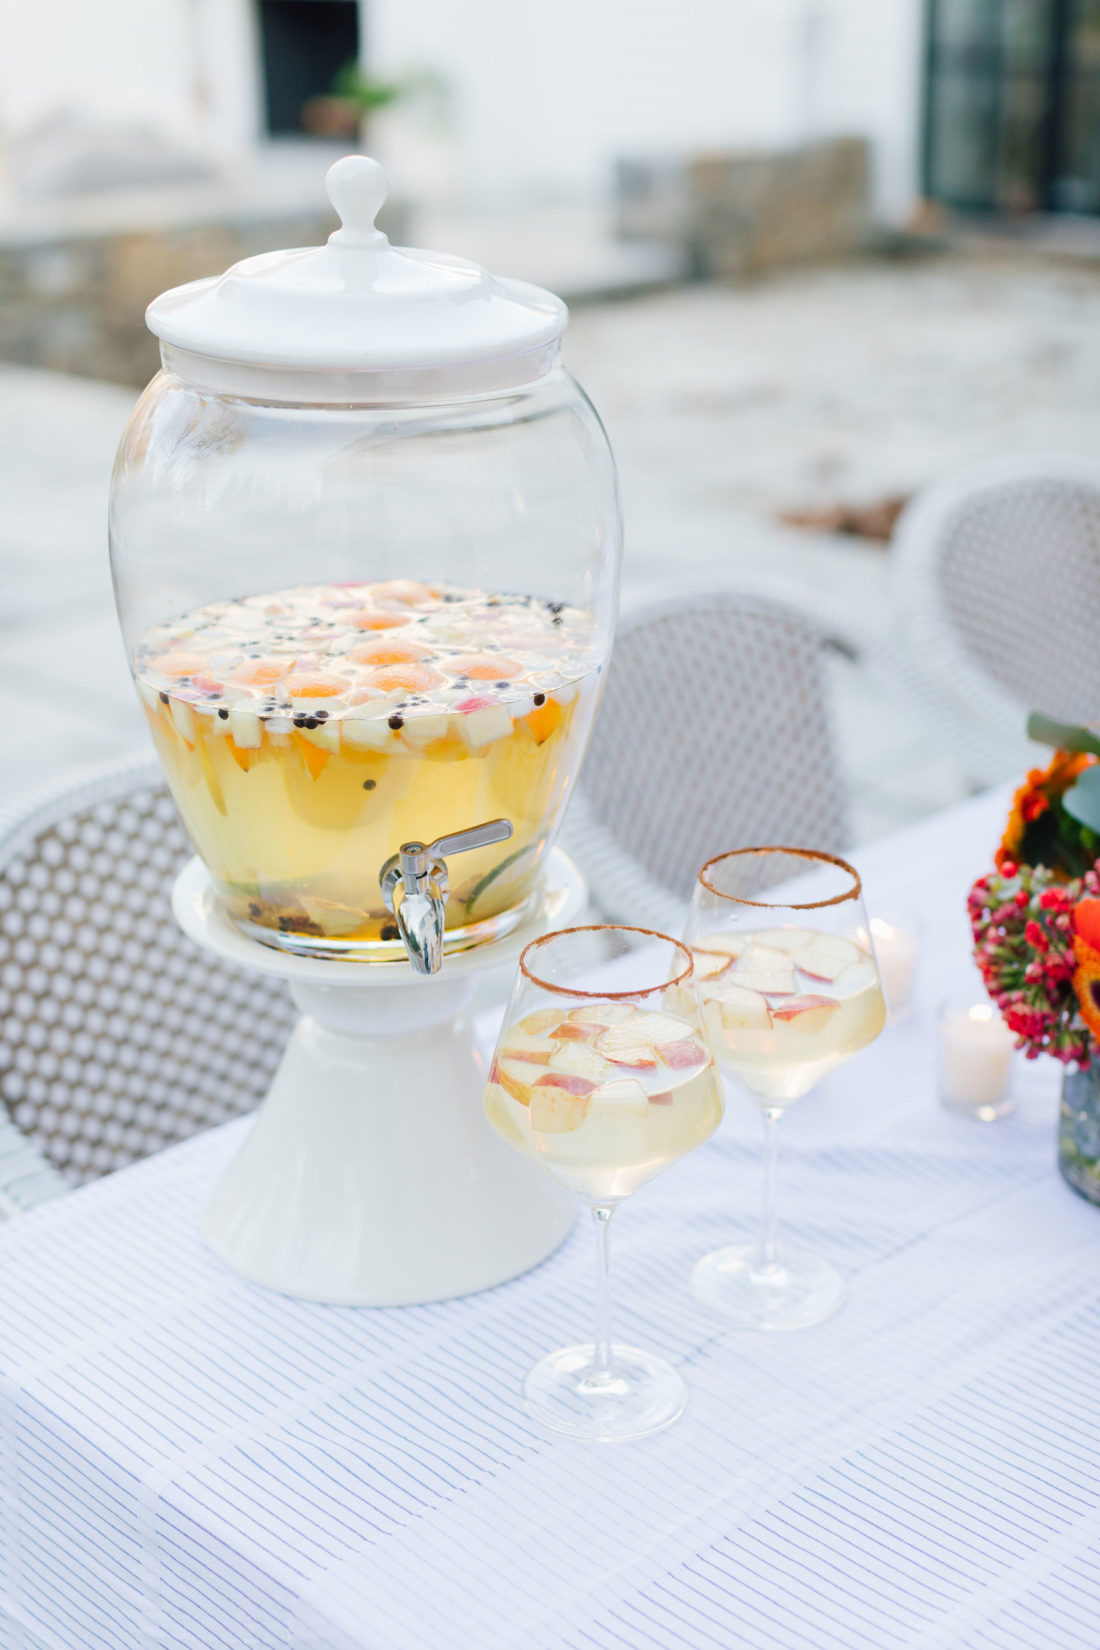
[[369, 0, 922, 219]]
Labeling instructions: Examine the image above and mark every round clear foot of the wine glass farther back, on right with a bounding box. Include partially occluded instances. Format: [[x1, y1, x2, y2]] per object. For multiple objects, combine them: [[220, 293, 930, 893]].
[[691, 1244, 844, 1330]]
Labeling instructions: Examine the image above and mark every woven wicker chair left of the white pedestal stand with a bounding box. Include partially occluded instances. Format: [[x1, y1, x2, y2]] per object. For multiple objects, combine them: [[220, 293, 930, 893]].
[[0, 762, 295, 1216]]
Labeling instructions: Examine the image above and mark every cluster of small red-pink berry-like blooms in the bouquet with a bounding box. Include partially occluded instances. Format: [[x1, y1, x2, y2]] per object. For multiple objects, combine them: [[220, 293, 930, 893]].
[[968, 860, 1100, 1066]]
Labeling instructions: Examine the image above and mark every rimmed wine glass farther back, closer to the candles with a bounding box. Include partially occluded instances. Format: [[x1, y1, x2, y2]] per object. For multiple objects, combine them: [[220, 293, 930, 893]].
[[684, 848, 886, 1330]]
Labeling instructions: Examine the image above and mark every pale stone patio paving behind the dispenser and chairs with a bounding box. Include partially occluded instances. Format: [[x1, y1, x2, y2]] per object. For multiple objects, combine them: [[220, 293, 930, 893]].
[[0, 254, 1100, 840]]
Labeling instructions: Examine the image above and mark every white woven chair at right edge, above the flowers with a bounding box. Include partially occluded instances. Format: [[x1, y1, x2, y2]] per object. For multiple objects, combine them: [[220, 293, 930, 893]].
[[892, 459, 1100, 784]]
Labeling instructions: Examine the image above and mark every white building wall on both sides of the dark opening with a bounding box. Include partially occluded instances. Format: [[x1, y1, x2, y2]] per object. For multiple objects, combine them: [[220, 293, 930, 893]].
[[0, 0, 922, 219]]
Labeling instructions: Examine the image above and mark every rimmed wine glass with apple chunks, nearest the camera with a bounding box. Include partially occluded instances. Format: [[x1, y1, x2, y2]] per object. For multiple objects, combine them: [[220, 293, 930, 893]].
[[485, 926, 724, 1442]]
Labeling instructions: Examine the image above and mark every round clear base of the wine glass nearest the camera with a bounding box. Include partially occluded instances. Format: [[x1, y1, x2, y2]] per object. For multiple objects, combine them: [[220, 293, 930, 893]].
[[523, 1343, 688, 1444]]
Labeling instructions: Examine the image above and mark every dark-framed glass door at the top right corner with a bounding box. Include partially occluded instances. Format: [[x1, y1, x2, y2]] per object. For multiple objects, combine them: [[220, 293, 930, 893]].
[[924, 0, 1100, 213]]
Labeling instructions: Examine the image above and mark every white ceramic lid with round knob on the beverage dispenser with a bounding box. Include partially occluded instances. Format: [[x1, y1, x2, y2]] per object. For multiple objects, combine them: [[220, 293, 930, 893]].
[[145, 155, 569, 380]]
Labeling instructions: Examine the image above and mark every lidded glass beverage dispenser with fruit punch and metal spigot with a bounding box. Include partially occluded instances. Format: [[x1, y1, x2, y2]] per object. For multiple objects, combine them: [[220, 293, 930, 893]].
[[110, 157, 620, 972]]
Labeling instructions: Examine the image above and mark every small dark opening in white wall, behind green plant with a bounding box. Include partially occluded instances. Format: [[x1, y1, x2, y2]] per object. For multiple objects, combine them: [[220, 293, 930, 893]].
[[259, 0, 360, 135]]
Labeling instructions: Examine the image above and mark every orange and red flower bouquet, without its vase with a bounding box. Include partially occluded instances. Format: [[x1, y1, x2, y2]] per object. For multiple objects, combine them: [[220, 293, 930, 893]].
[[968, 716, 1100, 1069]]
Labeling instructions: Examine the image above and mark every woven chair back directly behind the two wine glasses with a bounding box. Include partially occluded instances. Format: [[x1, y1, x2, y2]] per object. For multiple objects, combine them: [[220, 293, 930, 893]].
[[564, 584, 861, 934]]
